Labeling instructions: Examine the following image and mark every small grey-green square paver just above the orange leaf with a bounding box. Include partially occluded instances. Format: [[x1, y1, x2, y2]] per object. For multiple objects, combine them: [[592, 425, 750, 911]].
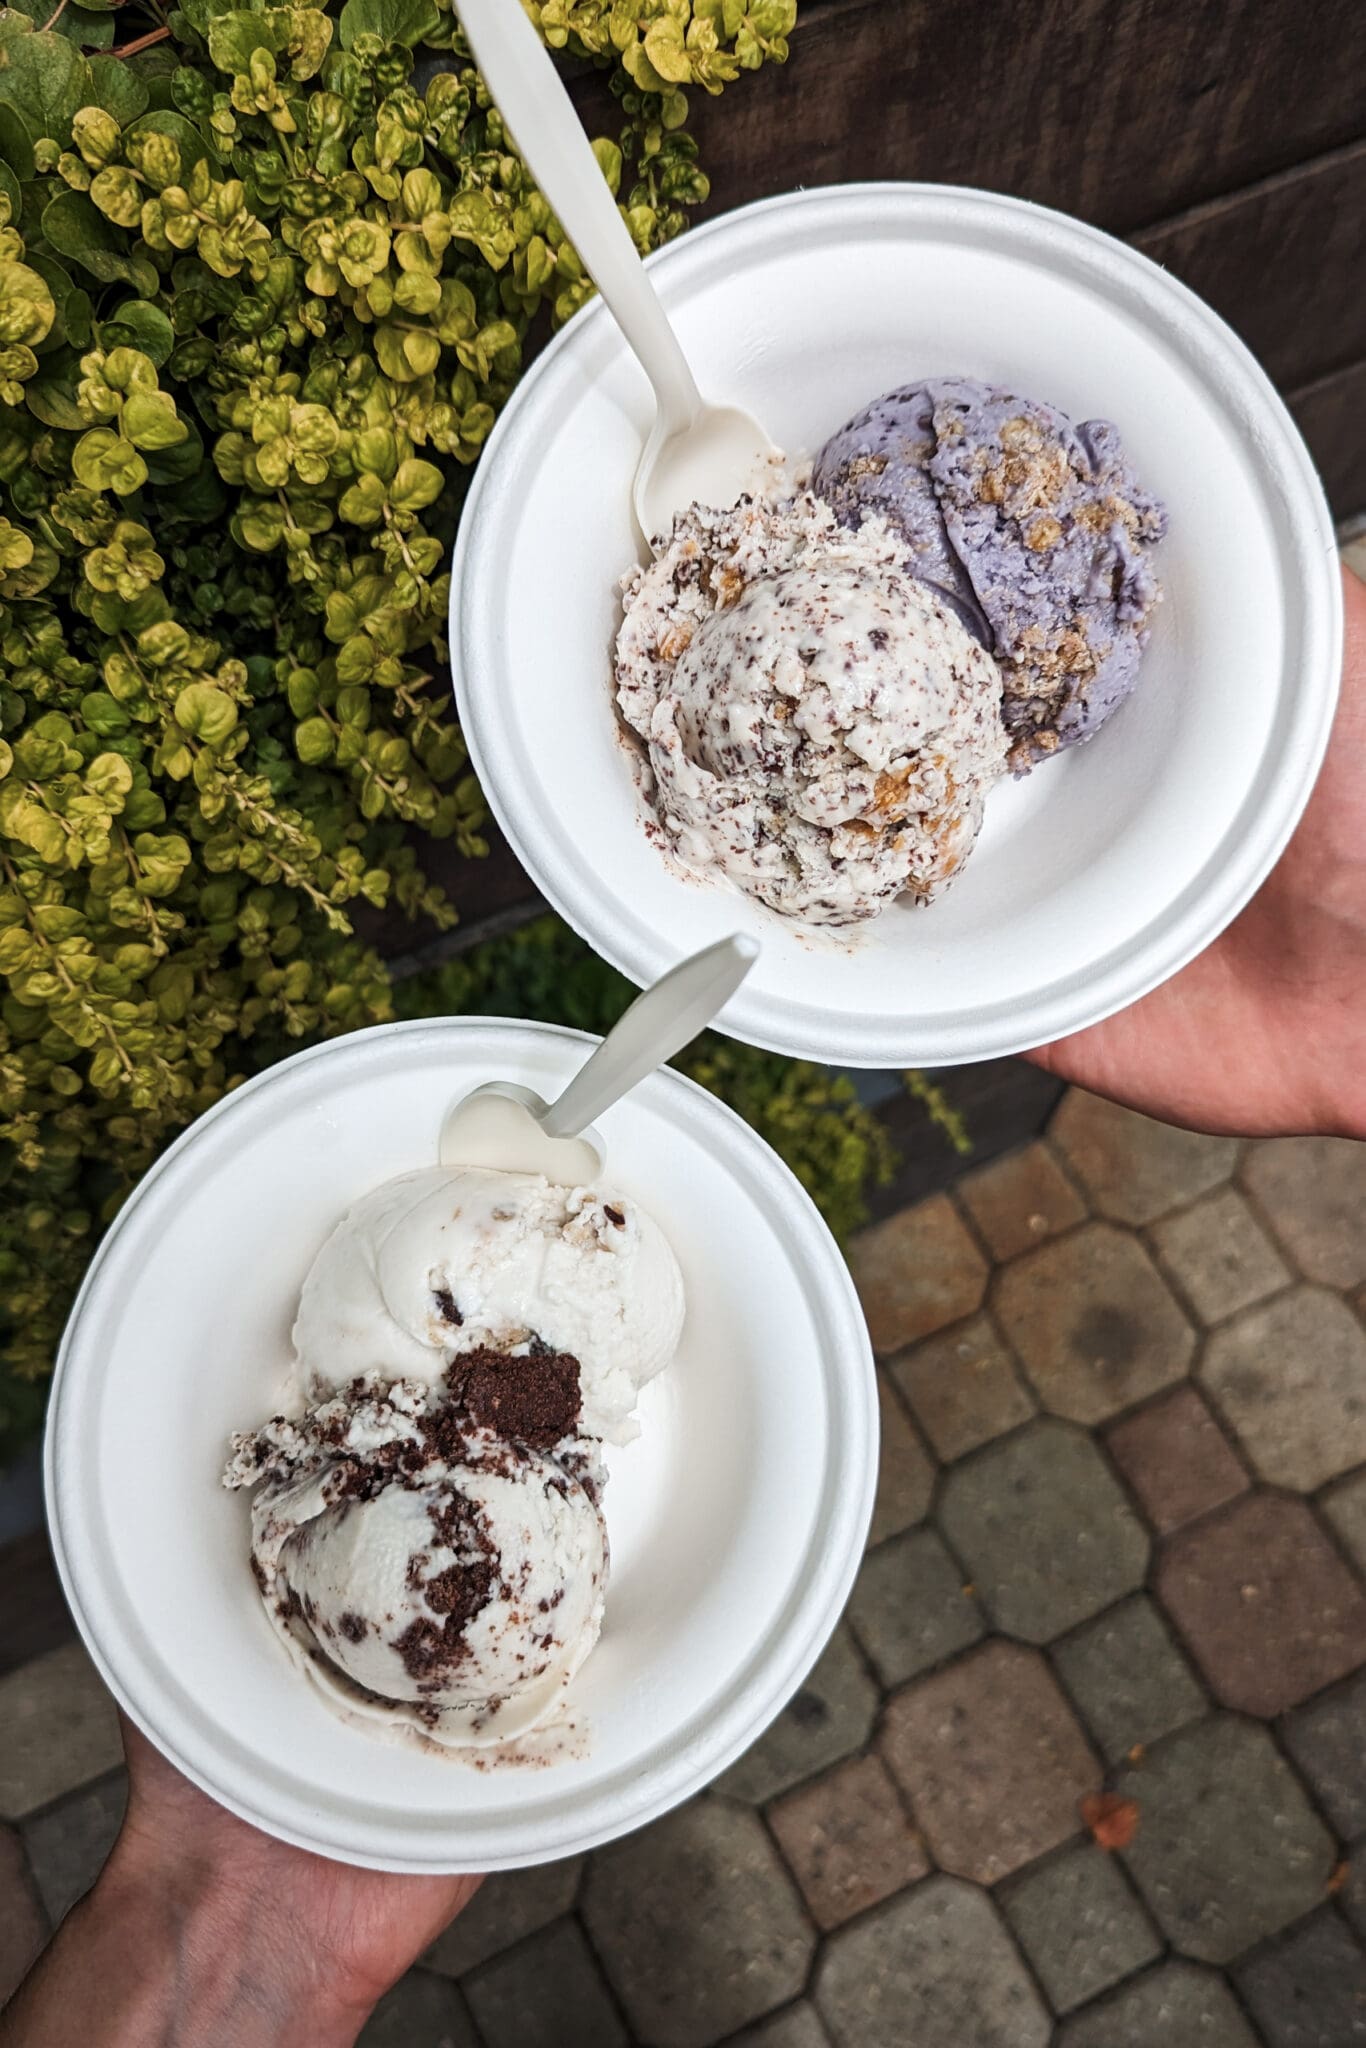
[[1053, 1593, 1204, 1763]]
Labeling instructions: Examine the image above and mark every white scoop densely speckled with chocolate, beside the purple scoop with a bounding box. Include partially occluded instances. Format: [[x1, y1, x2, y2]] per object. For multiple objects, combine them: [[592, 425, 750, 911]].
[[616, 492, 1006, 924]]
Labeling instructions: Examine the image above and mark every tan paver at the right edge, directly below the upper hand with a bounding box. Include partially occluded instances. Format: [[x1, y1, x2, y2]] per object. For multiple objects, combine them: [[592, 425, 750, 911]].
[[1243, 1139, 1366, 1288]]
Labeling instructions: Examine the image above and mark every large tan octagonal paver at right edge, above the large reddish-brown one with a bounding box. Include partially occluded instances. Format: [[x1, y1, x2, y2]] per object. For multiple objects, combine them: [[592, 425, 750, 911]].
[[1198, 1286, 1366, 1493]]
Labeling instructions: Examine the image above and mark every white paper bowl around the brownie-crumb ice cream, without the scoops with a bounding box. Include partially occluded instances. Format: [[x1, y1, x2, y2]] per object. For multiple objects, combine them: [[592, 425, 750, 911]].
[[47, 1018, 877, 1870]]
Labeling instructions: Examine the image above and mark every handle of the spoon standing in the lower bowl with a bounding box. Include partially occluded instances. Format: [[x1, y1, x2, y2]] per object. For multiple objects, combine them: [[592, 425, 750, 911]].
[[541, 932, 760, 1139]]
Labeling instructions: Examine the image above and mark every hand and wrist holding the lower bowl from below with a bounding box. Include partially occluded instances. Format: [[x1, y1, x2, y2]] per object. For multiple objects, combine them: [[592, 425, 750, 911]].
[[0, 1722, 479, 2048]]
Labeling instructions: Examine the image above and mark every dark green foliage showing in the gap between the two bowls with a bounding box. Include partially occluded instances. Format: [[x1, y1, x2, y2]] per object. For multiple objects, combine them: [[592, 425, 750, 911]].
[[395, 918, 895, 1241]]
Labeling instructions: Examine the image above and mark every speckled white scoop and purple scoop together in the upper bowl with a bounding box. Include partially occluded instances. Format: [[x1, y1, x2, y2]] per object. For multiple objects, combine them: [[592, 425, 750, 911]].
[[614, 377, 1165, 926]]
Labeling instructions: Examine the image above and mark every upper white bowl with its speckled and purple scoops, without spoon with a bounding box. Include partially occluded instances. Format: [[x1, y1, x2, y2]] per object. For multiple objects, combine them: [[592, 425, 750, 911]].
[[451, 184, 1341, 1067]]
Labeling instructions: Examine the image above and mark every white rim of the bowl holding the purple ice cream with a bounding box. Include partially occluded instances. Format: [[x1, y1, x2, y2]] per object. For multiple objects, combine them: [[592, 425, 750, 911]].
[[451, 180, 1343, 1067]]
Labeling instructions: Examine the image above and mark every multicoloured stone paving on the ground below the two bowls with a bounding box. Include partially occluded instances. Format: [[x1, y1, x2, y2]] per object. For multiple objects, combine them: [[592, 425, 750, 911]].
[[0, 1092, 1366, 2048]]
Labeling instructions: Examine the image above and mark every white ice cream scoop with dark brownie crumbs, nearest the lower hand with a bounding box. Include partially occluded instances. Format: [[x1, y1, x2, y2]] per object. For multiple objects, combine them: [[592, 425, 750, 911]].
[[227, 1358, 606, 1747]]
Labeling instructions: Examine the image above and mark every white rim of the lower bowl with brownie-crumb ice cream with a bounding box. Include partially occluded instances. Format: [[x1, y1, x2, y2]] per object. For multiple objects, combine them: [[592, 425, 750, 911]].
[[43, 1016, 879, 1872]]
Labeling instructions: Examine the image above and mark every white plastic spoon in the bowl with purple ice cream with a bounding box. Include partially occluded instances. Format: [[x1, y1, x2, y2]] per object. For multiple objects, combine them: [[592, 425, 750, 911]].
[[457, 0, 774, 541]]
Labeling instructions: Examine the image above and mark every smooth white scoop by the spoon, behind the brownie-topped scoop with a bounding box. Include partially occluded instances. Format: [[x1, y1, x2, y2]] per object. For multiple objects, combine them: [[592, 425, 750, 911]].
[[295, 1167, 684, 1444]]
